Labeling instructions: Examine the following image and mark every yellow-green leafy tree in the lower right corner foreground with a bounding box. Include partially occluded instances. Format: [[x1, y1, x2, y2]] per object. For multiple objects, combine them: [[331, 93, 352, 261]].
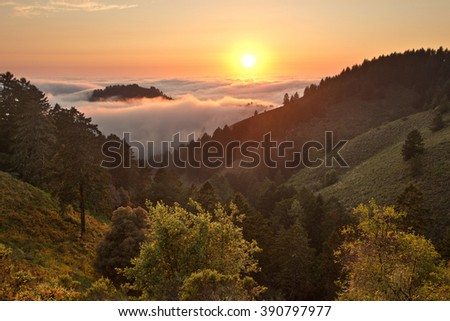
[[336, 200, 448, 300]]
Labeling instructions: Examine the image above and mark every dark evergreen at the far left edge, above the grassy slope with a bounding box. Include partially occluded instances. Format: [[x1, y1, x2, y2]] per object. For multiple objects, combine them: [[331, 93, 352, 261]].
[[0, 73, 55, 188]]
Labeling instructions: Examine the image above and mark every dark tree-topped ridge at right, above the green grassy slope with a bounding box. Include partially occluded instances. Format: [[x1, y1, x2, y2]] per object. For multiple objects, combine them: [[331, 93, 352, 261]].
[[207, 48, 450, 148]]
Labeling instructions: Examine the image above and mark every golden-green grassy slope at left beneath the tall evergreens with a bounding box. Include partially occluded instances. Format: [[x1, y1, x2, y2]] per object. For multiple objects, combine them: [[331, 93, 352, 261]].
[[0, 172, 107, 284]]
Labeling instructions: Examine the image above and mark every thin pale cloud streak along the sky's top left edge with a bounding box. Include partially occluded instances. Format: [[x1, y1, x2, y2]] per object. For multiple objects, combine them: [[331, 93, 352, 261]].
[[0, 0, 137, 17]]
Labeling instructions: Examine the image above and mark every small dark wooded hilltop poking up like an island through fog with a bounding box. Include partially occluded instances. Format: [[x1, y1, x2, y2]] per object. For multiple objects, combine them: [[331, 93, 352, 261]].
[[89, 84, 172, 101]]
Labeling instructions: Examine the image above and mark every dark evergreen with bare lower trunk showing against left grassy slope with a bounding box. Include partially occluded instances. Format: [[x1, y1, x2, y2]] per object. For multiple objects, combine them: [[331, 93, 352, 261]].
[[50, 105, 110, 236]]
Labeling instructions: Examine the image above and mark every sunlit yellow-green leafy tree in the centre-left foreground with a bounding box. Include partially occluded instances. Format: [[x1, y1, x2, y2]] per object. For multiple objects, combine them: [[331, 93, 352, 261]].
[[125, 201, 259, 300]]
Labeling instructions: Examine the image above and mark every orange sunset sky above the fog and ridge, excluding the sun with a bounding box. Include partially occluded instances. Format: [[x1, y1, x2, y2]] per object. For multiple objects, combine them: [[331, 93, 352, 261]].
[[0, 0, 450, 78]]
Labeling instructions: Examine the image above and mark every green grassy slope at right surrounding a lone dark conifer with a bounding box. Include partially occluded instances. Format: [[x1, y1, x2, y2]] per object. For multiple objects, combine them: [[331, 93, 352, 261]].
[[288, 111, 450, 221]]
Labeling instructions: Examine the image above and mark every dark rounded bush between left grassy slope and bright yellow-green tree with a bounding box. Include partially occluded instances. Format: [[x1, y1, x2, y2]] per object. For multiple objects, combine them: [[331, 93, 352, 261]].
[[94, 207, 148, 284]]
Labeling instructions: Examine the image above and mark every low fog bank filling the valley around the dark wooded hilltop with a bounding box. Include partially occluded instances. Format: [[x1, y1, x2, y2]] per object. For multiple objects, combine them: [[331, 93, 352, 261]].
[[32, 79, 311, 142]]
